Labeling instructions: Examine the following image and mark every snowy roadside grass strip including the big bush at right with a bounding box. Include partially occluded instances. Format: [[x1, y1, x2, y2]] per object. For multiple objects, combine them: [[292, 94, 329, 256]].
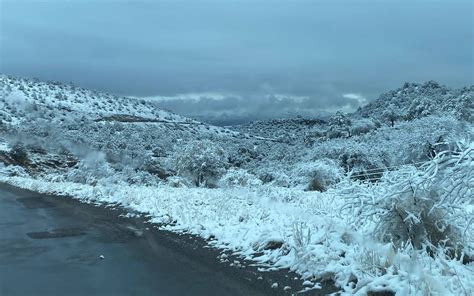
[[0, 143, 474, 295]]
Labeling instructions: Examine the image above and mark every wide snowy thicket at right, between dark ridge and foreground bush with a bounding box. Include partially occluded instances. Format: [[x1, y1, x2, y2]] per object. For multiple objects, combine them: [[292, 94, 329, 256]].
[[310, 115, 464, 173]]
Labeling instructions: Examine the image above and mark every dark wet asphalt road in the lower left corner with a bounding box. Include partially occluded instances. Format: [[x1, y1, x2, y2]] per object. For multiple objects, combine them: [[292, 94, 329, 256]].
[[0, 184, 267, 296]]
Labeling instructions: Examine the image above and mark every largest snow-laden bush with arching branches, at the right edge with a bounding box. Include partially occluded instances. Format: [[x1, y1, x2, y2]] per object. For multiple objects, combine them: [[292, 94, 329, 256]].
[[346, 143, 474, 257]]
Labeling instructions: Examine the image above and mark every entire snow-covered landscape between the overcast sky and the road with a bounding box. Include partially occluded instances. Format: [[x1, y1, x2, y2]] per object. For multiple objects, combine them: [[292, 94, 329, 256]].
[[0, 76, 474, 295]]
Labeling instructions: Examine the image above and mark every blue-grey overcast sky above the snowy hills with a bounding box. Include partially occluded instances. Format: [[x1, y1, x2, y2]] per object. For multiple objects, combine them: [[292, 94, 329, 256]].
[[0, 0, 474, 120]]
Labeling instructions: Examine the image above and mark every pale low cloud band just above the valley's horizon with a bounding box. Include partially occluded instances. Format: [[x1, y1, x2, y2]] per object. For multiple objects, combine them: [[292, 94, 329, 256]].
[[146, 93, 366, 125]]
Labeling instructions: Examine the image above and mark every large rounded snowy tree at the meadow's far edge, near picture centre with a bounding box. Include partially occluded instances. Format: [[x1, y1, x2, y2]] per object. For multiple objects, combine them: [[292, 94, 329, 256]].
[[175, 140, 228, 187]]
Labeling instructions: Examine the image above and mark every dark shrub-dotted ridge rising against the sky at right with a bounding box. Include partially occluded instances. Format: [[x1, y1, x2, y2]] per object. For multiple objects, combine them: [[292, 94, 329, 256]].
[[231, 81, 474, 141]]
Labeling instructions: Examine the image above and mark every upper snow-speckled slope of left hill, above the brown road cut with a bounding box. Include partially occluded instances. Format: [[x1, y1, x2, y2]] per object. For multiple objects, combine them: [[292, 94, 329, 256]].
[[0, 75, 193, 122]]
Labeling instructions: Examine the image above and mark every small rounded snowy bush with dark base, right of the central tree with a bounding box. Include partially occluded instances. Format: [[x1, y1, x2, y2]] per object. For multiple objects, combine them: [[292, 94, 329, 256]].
[[294, 158, 344, 192]]
